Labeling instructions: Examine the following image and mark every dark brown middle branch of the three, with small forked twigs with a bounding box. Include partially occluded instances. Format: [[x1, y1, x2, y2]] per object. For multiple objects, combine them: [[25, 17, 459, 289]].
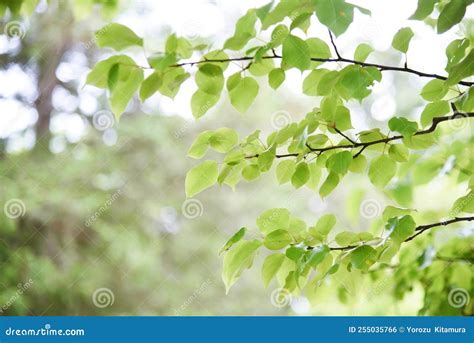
[[246, 112, 474, 158]]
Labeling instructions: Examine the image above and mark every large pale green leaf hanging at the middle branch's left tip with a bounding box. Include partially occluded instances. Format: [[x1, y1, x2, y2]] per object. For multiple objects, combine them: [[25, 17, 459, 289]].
[[185, 161, 218, 197]]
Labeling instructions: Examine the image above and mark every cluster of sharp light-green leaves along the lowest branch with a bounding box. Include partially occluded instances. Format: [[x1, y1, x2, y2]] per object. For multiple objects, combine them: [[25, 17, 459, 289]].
[[222, 206, 432, 292]]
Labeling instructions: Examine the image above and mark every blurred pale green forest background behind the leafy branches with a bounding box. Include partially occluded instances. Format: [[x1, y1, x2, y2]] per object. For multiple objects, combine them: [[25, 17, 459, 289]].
[[0, 0, 472, 315]]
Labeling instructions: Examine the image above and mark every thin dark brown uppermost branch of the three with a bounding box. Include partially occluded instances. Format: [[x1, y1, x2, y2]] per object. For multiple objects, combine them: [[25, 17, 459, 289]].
[[170, 53, 474, 87]]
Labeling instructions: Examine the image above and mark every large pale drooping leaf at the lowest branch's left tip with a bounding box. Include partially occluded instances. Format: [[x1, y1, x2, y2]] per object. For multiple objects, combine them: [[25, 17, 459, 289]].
[[222, 240, 262, 293]]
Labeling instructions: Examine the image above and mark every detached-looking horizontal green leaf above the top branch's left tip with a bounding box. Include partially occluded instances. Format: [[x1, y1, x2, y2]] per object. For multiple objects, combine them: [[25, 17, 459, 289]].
[[95, 23, 143, 51]]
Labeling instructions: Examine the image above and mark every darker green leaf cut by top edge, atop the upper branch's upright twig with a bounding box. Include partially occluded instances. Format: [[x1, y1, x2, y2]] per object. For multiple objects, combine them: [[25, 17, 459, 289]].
[[314, 0, 354, 36]]
